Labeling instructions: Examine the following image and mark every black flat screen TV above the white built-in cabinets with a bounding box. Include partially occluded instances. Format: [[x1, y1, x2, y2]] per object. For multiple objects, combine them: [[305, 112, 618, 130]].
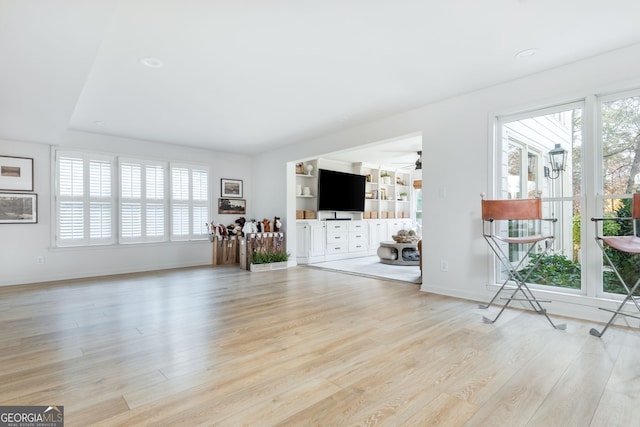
[[318, 169, 366, 212]]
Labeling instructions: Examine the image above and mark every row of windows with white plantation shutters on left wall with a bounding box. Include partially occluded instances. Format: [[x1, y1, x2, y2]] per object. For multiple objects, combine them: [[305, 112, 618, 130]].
[[55, 151, 210, 247]]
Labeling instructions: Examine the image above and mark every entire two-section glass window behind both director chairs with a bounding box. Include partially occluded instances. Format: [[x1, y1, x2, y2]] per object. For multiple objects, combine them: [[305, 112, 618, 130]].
[[495, 91, 640, 298]]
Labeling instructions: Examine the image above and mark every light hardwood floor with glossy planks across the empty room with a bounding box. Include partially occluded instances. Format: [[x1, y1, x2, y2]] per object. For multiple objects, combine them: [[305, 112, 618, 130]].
[[0, 267, 640, 426]]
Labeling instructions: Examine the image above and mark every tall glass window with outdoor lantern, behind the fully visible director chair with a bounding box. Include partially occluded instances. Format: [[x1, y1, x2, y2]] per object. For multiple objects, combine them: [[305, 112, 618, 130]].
[[496, 104, 583, 292]]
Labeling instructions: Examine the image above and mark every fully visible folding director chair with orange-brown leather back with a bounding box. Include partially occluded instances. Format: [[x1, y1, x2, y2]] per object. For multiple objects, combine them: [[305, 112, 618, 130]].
[[480, 194, 566, 329]]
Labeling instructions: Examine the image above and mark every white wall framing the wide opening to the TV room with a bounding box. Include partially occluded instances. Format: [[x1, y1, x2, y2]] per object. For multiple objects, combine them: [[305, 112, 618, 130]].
[[255, 45, 640, 324]]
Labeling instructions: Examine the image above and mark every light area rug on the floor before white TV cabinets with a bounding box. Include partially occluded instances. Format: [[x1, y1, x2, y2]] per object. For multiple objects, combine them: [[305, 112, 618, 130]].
[[306, 255, 422, 283]]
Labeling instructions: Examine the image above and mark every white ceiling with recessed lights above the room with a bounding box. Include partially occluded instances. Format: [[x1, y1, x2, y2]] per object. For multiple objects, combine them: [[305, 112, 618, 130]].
[[0, 0, 640, 166]]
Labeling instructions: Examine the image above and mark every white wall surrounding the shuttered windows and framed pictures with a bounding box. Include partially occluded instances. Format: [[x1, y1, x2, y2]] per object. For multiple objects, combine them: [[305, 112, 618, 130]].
[[0, 132, 255, 285]]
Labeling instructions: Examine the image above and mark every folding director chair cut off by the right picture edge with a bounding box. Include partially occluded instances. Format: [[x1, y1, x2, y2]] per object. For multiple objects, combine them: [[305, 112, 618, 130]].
[[589, 193, 640, 337]]
